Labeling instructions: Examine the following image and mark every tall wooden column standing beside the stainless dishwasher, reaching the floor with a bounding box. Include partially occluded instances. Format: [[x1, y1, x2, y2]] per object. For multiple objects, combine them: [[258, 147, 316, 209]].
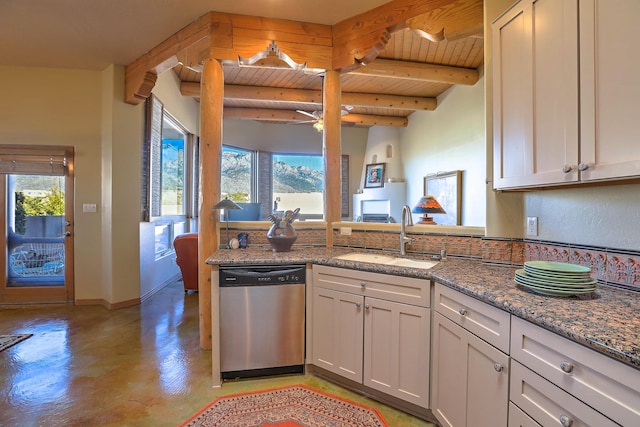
[[198, 59, 224, 356]]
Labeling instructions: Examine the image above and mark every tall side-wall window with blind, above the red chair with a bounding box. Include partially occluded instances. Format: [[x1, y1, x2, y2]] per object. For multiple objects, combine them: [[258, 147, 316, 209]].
[[141, 95, 197, 258]]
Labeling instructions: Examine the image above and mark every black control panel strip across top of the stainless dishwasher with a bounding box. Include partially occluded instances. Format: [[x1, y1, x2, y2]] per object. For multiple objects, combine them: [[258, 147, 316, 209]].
[[220, 264, 307, 287]]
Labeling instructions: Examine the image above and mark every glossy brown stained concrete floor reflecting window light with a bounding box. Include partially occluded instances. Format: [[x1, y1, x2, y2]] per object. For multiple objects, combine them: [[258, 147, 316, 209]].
[[0, 283, 432, 427]]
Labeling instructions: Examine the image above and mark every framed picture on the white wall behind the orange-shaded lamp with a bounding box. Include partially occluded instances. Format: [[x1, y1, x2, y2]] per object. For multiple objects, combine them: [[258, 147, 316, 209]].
[[424, 170, 462, 225]]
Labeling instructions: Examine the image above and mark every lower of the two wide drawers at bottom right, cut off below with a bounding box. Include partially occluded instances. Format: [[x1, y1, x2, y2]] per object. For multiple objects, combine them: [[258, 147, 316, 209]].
[[509, 360, 618, 427]]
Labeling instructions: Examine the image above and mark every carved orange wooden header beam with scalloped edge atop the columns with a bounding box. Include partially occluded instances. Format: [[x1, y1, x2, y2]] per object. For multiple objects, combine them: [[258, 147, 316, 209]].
[[125, 0, 482, 105]]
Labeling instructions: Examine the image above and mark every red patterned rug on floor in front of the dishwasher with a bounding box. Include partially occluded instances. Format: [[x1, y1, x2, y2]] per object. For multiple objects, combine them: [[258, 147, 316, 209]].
[[181, 385, 388, 427]]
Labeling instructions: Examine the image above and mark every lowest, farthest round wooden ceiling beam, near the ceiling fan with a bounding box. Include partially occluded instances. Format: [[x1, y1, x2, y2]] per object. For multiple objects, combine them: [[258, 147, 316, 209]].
[[224, 107, 409, 127]]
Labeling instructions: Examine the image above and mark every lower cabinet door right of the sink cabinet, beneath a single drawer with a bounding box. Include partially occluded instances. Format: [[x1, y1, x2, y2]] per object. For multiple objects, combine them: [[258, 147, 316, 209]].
[[431, 313, 509, 427]]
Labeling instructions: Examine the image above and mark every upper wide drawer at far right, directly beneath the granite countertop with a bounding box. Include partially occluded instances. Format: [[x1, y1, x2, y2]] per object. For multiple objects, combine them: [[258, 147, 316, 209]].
[[511, 316, 640, 426]]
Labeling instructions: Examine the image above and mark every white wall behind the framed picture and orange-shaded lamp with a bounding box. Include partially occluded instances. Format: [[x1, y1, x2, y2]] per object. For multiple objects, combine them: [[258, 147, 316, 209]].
[[400, 72, 486, 227]]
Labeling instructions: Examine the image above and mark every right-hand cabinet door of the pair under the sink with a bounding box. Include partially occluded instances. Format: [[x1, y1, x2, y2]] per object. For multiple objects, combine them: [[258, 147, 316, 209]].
[[363, 298, 430, 408]]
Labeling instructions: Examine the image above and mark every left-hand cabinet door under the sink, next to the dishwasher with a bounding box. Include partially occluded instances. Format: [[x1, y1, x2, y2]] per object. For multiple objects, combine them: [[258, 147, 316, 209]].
[[312, 288, 364, 383]]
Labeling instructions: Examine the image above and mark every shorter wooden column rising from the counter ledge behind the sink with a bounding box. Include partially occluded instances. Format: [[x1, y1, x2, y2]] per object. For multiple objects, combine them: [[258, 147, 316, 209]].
[[322, 70, 342, 246]]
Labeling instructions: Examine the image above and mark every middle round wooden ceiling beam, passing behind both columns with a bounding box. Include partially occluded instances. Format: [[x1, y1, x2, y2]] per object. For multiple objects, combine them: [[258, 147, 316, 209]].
[[180, 82, 437, 111]]
